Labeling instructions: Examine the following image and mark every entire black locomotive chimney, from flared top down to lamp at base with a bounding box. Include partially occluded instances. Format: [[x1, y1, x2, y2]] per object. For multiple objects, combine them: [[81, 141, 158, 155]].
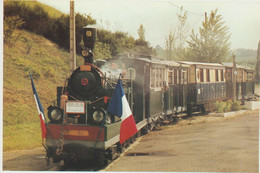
[[82, 26, 97, 64]]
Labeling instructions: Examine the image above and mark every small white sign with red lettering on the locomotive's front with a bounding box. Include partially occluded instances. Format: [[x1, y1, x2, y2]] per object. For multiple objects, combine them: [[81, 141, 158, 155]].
[[66, 101, 85, 114]]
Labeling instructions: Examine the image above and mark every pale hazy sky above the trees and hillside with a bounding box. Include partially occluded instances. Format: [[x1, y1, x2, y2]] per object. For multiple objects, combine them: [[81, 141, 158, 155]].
[[39, 0, 260, 49]]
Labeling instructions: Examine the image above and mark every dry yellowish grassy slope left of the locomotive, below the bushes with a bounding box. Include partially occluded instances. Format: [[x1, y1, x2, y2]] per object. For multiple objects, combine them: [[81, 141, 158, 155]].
[[3, 30, 83, 150]]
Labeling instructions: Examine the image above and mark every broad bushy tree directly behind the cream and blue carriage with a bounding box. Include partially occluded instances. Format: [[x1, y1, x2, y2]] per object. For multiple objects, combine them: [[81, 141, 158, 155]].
[[186, 9, 231, 63]]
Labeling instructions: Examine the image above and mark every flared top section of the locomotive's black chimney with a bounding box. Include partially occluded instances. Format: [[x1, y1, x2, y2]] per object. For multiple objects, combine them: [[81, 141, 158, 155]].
[[83, 26, 97, 51]]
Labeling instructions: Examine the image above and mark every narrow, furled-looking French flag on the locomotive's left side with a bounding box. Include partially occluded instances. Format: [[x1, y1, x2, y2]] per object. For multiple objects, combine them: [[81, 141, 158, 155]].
[[30, 73, 47, 139]]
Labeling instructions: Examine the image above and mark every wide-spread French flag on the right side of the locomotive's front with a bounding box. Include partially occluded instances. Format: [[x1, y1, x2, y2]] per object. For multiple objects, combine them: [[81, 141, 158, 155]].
[[107, 79, 137, 144]]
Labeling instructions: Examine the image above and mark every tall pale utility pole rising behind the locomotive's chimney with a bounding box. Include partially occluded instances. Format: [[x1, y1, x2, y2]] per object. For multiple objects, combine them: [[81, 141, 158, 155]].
[[70, 0, 76, 71]]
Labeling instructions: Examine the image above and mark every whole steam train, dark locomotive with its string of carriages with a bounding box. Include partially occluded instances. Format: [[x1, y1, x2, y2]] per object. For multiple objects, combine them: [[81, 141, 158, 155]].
[[45, 27, 254, 165]]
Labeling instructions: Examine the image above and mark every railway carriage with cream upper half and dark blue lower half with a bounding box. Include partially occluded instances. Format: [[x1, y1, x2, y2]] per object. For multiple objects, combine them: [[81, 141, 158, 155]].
[[179, 61, 226, 115]]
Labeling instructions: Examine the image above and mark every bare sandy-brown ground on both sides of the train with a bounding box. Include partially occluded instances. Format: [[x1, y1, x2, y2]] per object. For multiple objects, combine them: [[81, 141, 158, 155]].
[[3, 111, 259, 172]]
